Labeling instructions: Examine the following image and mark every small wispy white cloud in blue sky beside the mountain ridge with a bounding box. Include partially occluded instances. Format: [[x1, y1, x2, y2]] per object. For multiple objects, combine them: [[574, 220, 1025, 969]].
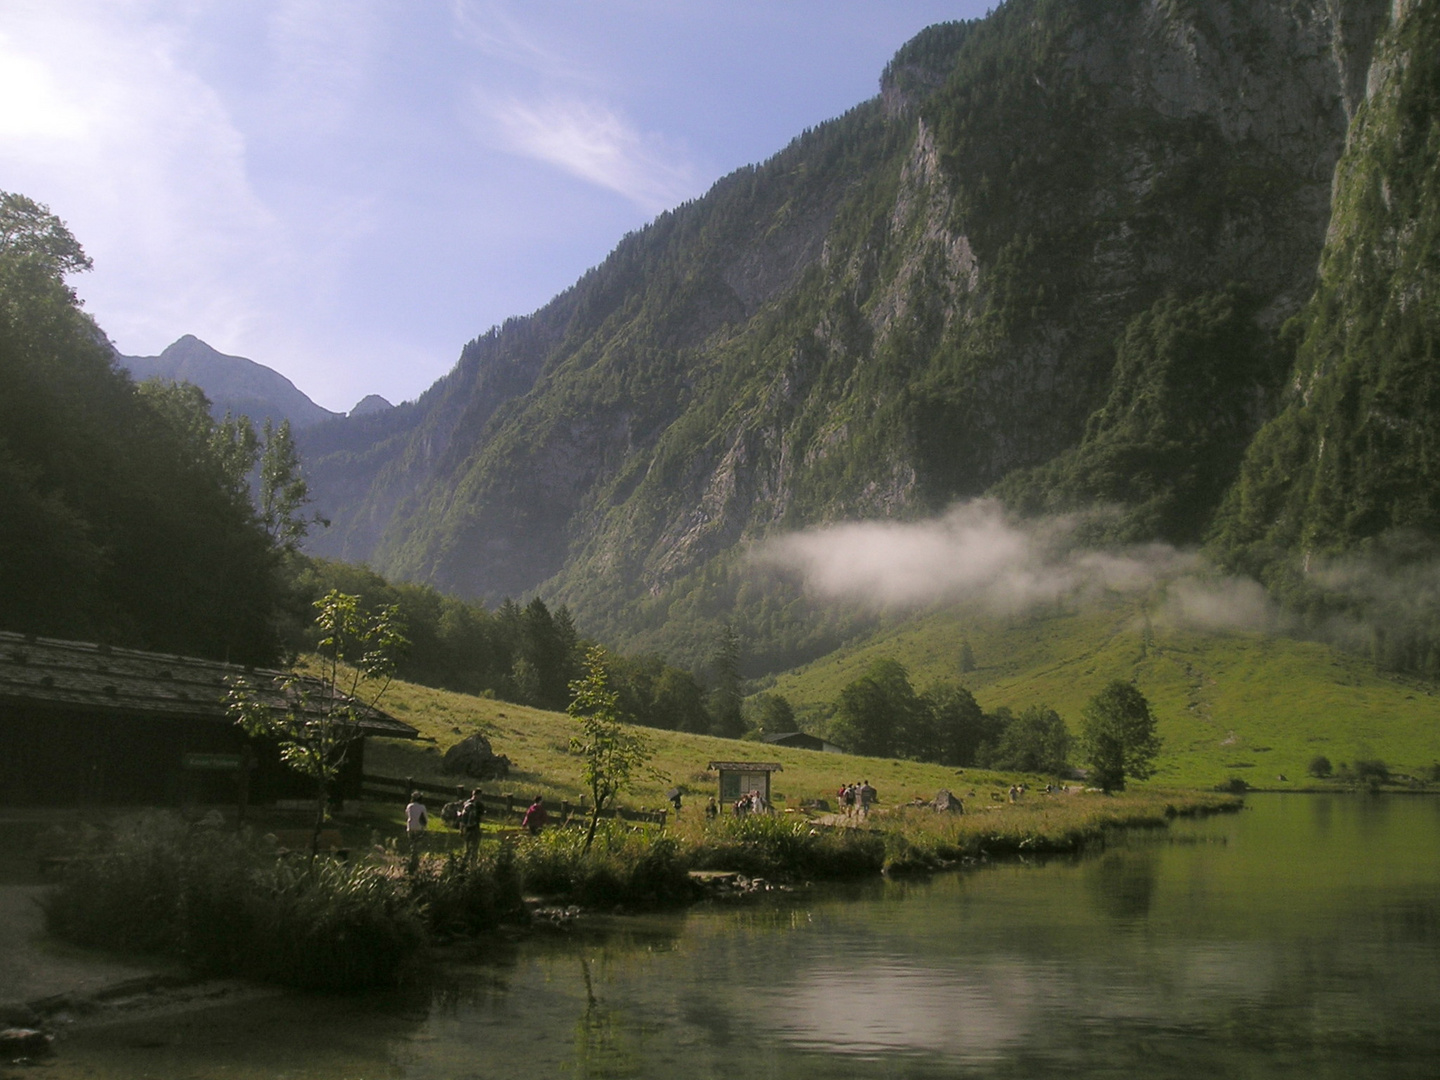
[[472, 91, 700, 213]]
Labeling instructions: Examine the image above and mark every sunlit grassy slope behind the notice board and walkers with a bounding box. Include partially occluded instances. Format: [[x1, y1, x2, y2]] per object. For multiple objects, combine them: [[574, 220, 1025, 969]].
[[366, 683, 1048, 808]]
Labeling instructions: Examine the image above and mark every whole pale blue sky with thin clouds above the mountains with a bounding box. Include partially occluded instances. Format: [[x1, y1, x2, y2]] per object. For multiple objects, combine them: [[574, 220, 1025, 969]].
[[0, 0, 991, 409]]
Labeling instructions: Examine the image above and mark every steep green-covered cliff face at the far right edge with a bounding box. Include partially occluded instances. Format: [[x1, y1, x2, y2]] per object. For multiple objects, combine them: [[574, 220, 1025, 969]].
[[1211, 4, 1440, 677]]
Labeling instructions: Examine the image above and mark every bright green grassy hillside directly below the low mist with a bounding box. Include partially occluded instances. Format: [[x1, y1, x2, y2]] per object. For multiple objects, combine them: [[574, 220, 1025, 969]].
[[772, 596, 1440, 789]]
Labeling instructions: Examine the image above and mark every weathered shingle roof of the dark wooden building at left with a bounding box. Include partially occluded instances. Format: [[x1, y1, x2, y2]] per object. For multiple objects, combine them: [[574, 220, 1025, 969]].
[[0, 631, 419, 739]]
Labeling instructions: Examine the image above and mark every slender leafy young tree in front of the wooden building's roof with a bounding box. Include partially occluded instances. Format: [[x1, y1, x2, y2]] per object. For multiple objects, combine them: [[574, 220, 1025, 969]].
[[228, 589, 406, 857]]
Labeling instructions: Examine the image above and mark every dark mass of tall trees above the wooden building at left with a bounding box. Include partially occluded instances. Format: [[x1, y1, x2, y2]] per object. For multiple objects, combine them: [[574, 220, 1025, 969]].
[[0, 194, 285, 664]]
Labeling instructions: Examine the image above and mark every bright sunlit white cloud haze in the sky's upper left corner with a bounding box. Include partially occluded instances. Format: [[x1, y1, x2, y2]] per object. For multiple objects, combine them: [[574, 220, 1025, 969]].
[[0, 1, 285, 346]]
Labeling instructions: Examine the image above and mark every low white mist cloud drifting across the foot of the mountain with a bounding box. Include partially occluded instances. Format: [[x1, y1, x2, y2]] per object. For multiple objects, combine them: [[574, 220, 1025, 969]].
[[756, 500, 1279, 629]]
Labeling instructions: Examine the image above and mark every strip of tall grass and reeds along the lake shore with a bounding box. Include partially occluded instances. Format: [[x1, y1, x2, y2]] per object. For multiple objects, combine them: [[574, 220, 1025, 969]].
[[46, 792, 1240, 991]]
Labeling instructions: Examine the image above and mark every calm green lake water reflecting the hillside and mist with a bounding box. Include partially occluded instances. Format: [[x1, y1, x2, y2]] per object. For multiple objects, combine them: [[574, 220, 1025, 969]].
[[46, 795, 1440, 1080]]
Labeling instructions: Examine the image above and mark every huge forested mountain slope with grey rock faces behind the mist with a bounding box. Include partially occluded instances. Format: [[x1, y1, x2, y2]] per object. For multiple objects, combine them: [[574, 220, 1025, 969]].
[[295, 0, 1440, 673]]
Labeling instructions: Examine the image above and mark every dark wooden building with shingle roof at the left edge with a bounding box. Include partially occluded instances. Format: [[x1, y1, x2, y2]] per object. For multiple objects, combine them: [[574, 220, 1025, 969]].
[[0, 632, 419, 806]]
